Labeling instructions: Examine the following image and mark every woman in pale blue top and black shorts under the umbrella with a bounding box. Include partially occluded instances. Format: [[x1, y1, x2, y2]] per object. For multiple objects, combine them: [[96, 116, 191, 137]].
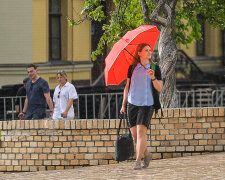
[[120, 43, 163, 169]]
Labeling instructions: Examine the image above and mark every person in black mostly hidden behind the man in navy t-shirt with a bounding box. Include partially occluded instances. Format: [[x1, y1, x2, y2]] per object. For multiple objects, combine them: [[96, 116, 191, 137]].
[[15, 77, 29, 117]]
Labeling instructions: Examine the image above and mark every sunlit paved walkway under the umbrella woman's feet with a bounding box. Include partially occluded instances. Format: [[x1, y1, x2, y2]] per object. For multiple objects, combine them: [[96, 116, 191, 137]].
[[0, 152, 225, 180]]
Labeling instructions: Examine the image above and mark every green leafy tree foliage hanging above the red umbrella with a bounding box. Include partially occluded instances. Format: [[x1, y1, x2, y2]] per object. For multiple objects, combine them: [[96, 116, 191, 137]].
[[72, 0, 225, 61]]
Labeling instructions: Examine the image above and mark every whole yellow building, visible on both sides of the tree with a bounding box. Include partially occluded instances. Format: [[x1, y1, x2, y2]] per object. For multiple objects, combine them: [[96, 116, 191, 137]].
[[0, 0, 225, 89]]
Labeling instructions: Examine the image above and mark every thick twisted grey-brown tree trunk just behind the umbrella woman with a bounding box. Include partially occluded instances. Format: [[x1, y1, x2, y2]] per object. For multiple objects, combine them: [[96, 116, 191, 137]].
[[141, 0, 178, 108]]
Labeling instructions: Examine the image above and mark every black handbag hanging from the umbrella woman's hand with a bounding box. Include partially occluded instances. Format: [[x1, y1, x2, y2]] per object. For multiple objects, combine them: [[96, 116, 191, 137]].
[[115, 115, 134, 161]]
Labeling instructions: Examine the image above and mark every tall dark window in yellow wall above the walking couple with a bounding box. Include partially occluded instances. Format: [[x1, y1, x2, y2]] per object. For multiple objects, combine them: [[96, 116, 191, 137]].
[[49, 0, 61, 61]]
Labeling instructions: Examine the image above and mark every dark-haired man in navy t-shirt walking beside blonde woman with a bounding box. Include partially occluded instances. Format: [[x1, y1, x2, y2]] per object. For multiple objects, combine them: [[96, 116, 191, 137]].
[[18, 64, 53, 120]]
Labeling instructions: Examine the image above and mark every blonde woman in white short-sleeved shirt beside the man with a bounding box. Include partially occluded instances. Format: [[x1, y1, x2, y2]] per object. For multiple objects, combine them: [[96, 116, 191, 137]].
[[53, 70, 78, 119]]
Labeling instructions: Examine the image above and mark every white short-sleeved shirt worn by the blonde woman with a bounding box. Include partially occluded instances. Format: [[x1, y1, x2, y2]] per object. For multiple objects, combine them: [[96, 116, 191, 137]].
[[53, 82, 78, 119]]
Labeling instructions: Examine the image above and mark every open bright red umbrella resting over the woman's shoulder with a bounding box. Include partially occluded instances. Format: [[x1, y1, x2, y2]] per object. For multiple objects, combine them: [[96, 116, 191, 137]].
[[104, 25, 160, 85]]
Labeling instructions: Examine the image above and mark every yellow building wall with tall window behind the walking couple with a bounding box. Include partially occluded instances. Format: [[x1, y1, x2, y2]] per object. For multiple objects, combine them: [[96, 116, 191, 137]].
[[0, 0, 92, 89]]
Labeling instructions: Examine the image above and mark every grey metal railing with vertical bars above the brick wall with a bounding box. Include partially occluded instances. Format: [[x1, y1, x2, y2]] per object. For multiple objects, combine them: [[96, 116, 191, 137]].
[[0, 89, 225, 120]]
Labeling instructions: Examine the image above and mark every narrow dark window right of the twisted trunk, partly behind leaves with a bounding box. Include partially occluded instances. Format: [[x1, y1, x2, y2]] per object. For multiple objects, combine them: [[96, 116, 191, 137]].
[[196, 17, 205, 56]]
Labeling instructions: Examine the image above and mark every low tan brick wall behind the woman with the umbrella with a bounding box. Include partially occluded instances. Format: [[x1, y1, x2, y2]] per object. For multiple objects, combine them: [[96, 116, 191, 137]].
[[0, 108, 225, 172]]
